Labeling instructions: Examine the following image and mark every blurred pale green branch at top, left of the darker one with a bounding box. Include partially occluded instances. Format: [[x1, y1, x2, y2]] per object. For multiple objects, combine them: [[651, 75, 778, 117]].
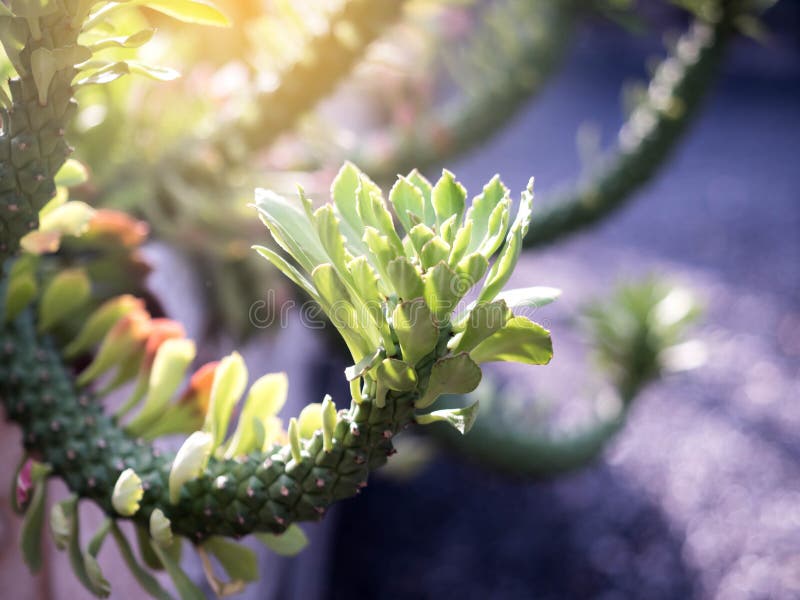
[[354, 0, 578, 181]]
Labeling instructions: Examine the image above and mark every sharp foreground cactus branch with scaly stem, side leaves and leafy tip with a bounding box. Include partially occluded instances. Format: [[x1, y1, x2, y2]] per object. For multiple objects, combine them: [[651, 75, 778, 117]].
[[0, 157, 552, 596]]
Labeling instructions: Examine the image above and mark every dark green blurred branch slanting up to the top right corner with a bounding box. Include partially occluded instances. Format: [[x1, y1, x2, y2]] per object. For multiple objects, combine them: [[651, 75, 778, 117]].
[[525, 7, 739, 248]]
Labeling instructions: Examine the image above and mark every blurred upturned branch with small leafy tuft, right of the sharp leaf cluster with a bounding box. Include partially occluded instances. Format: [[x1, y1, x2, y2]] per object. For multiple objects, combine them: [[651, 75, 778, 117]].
[[430, 279, 699, 478]]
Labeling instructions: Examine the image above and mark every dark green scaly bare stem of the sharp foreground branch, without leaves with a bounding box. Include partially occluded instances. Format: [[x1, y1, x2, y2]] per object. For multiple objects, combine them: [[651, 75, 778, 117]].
[[0, 315, 424, 542]]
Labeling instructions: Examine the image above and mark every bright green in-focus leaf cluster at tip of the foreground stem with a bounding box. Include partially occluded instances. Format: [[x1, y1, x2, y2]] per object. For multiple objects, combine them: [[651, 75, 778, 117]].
[[255, 163, 558, 428]]
